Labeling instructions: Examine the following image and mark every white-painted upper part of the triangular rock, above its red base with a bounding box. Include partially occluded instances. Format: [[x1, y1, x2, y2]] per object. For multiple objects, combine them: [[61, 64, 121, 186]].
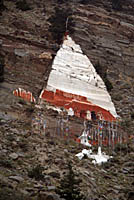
[[47, 36, 117, 117]]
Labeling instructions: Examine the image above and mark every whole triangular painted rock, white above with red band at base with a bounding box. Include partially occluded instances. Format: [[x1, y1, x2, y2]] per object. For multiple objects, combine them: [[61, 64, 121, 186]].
[[40, 35, 117, 121]]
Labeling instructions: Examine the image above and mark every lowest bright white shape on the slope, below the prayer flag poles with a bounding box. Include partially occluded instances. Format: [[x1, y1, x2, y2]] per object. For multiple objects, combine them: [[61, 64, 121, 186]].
[[76, 147, 112, 165]]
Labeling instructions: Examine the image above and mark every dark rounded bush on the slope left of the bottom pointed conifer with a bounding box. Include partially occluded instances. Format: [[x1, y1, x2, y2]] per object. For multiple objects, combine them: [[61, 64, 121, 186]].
[[28, 165, 44, 180]]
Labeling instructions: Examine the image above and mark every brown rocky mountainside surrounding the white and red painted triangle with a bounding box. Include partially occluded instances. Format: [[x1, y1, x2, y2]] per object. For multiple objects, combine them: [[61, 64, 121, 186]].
[[0, 0, 134, 200]]
